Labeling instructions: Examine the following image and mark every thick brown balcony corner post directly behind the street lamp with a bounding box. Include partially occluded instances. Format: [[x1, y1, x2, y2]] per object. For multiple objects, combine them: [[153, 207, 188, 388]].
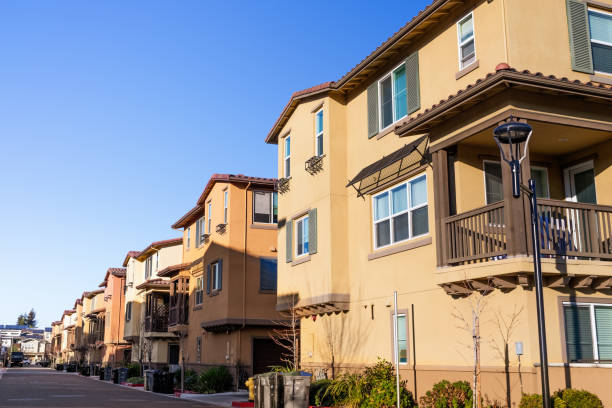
[[500, 144, 531, 256]]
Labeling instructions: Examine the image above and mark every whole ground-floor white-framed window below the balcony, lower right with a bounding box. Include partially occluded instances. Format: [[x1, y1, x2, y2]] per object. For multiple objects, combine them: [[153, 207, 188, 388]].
[[563, 303, 612, 362]]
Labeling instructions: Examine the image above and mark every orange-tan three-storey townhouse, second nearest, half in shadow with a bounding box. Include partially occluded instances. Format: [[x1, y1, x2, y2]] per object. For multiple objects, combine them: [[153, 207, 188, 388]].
[[170, 174, 282, 384]]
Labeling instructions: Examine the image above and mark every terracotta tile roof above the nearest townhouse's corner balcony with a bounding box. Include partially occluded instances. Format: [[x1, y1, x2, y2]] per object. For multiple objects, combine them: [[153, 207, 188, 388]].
[[395, 63, 612, 136]]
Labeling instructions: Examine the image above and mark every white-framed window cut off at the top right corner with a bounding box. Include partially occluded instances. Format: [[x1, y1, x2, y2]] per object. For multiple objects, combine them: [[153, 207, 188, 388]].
[[589, 9, 612, 74]]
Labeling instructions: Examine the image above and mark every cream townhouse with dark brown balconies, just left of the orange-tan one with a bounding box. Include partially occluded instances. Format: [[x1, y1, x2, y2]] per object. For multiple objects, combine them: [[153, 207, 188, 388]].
[[123, 238, 183, 368]]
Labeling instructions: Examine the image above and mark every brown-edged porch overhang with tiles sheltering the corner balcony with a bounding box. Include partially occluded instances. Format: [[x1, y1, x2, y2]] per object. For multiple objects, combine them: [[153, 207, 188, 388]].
[[395, 68, 612, 137]]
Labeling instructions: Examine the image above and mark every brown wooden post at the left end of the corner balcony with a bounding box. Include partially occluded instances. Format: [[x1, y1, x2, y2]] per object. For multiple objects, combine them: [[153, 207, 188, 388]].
[[432, 149, 450, 267]]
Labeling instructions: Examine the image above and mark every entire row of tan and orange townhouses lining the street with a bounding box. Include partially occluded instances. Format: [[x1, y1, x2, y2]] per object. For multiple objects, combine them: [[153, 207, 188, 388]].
[[54, 0, 612, 404]]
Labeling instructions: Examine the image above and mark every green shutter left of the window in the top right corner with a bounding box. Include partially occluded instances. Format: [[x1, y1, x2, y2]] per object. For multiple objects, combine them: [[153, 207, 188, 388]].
[[566, 0, 593, 74]]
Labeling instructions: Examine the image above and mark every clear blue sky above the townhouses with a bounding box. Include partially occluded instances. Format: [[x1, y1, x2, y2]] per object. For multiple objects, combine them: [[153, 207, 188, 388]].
[[0, 0, 428, 325]]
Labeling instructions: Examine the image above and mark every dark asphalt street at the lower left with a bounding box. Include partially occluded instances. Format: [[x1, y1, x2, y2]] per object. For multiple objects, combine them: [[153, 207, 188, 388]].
[[0, 368, 220, 408]]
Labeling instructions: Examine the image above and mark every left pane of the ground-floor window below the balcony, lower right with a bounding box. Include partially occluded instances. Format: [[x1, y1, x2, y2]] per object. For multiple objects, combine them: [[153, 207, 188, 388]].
[[563, 306, 594, 362]]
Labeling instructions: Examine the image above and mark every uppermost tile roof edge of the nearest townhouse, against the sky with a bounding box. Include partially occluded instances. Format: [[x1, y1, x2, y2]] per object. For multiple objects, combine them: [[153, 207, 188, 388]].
[[266, 0, 459, 143]]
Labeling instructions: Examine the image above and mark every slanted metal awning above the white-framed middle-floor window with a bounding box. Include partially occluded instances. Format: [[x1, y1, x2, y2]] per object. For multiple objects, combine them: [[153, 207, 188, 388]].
[[346, 136, 430, 197]]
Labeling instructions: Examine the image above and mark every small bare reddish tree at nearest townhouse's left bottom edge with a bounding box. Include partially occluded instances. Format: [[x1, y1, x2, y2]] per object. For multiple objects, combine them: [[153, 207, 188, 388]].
[[270, 295, 300, 371]]
